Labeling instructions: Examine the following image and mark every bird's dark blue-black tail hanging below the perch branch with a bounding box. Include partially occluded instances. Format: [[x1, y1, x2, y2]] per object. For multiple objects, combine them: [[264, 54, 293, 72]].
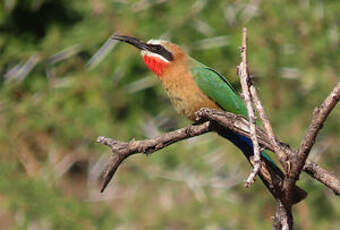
[[217, 129, 307, 204]]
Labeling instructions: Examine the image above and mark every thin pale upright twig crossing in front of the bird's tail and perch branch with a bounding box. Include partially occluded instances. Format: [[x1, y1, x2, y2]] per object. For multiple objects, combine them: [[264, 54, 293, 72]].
[[238, 28, 261, 187]]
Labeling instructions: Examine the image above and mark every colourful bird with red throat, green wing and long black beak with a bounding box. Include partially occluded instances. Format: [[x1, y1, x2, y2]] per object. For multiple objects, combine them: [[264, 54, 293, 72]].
[[111, 34, 307, 203]]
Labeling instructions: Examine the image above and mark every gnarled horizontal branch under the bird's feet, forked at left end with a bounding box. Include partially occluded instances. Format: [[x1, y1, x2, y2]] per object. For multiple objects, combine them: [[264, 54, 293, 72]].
[[97, 108, 340, 194]]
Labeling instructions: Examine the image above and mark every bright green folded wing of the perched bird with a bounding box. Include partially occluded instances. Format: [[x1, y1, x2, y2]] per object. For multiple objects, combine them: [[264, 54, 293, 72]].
[[191, 67, 248, 116]]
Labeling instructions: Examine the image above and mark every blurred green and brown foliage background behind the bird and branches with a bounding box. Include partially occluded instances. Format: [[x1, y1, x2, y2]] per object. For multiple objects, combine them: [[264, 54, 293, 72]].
[[0, 0, 340, 230]]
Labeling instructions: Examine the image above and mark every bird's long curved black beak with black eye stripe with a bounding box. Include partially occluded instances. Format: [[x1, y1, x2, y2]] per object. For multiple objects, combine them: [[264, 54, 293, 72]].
[[112, 34, 174, 61]]
